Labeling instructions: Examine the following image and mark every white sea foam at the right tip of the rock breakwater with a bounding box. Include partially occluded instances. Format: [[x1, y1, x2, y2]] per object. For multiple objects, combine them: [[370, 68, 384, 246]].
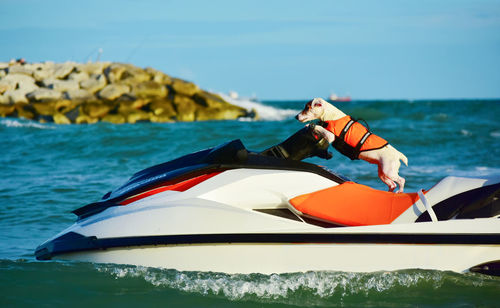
[[219, 93, 300, 121]]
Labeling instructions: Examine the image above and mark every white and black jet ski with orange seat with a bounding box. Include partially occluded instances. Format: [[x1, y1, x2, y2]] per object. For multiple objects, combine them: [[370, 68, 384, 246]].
[[35, 127, 500, 275]]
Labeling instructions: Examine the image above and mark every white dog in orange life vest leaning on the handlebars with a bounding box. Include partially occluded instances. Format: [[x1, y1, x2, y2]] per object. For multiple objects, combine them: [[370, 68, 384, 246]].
[[295, 98, 408, 192]]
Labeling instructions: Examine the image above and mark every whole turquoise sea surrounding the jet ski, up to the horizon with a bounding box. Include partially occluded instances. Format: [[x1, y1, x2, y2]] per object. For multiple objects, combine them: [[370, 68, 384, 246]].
[[0, 101, 500, 307]]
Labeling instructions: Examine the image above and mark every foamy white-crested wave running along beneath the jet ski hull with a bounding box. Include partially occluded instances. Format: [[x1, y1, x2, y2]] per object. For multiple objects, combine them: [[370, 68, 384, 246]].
[[97, 265, 496, 307]]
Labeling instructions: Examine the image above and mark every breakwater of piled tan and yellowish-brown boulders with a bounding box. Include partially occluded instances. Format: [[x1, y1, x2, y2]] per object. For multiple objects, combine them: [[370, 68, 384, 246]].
[[0, 62, 256, 124]]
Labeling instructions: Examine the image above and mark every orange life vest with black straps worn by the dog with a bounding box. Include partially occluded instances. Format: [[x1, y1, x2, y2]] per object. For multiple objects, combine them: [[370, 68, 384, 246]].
[[326, 116, 388, 160]]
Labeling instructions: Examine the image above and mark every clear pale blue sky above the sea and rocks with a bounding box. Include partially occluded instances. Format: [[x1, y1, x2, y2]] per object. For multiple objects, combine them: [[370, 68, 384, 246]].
[[0, 0, 500, 100]]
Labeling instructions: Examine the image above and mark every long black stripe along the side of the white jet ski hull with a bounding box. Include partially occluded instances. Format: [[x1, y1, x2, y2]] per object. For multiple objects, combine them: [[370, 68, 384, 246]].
[[35, 232, 500, 260]]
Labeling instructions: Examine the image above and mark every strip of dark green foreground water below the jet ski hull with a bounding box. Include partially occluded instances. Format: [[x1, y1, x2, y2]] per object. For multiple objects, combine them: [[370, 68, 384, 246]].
[[0, 257, 500, 307]]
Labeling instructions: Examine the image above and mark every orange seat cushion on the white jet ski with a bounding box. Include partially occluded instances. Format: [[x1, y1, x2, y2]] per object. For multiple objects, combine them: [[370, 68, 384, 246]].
[[290, 182, 419, 226]]
